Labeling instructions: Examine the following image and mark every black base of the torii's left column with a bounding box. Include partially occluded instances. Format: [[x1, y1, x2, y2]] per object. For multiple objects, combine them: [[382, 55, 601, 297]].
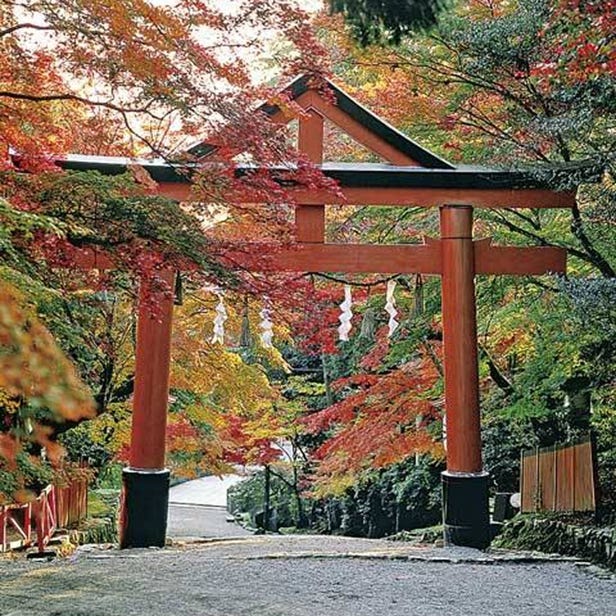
[[120, 468, 169, 549]]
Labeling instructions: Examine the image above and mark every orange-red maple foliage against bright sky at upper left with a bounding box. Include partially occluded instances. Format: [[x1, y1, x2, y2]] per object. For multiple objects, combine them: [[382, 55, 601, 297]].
[[0, 0, 334, 288]]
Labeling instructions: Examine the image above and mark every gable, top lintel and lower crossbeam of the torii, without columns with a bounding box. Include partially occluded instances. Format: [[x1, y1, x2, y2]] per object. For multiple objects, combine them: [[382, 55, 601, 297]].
[[58, 70, 574, 274]]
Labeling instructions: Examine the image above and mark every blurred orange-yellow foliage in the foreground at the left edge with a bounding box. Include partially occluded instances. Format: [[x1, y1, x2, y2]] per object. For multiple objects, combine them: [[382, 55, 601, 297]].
[[0, 274, 94, 503]]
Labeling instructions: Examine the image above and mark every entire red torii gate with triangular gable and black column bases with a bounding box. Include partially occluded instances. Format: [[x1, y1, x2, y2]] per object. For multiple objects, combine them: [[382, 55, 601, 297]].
[[60, 76, 575, 547]]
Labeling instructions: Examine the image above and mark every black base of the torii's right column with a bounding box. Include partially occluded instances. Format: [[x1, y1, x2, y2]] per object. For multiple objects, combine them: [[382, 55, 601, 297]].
[[441, 471, 490, 550]]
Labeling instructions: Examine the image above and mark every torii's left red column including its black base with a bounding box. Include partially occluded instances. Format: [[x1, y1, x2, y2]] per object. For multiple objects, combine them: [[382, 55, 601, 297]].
[[120, 270, 174, 548]]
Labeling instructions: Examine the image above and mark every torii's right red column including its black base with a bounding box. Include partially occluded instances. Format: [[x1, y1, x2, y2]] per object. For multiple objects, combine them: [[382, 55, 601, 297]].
[[440, 205, 490, 548]]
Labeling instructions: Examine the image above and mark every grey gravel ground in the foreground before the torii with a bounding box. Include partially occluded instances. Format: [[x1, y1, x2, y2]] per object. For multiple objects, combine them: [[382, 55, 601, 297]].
[[0, 536, 616, 616]]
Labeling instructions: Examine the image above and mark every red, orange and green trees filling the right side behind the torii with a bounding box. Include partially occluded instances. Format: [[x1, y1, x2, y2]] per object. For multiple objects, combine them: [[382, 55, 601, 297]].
[[308, 0, 616, 506]]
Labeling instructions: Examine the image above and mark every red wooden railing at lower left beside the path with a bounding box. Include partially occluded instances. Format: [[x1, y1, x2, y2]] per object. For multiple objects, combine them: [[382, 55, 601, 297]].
[[0, 478, 88, 552]]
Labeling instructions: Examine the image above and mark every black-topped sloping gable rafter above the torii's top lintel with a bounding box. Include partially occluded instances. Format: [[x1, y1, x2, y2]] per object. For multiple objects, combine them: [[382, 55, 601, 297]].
[[187, 75, 455, 169]]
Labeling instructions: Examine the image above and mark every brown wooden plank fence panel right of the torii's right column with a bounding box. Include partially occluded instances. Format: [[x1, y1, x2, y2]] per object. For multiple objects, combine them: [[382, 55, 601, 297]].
[[520, 438, 597, 513]]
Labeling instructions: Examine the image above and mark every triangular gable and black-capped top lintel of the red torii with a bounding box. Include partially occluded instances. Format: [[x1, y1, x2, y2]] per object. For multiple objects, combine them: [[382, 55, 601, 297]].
[[57, 75, 574, 213]]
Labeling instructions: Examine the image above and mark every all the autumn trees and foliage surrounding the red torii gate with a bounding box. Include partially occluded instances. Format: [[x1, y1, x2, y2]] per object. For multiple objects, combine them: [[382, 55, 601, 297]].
[[0, 0, 616, 536]]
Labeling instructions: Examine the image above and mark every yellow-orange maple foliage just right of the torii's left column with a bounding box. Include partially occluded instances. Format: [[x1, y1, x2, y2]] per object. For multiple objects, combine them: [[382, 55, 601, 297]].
[[166, 292, 286, 472]]
